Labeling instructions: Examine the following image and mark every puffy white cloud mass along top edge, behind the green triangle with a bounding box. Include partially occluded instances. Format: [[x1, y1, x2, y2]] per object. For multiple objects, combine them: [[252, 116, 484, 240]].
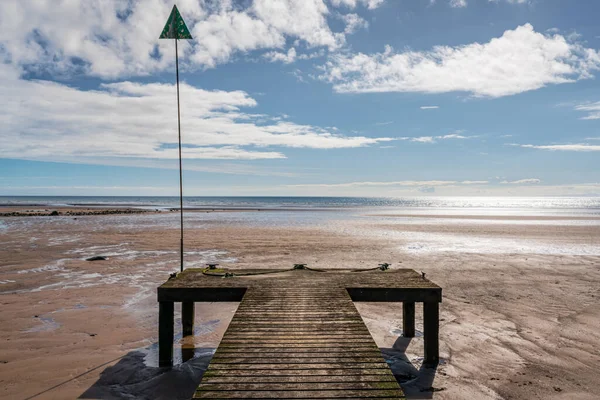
[[0, 0, 358, 79]]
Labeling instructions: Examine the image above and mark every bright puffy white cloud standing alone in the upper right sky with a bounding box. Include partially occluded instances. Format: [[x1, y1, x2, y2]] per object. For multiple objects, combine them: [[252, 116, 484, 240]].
[[320, 24, 600, 97]]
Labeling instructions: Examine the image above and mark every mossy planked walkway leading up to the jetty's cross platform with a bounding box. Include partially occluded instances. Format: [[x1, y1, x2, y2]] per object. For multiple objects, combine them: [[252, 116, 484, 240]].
[[194, 287, 404, 399]]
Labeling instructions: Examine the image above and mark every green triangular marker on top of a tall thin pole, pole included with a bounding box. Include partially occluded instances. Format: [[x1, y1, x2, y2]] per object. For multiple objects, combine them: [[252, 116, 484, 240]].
[[159, 5, 192, 271]]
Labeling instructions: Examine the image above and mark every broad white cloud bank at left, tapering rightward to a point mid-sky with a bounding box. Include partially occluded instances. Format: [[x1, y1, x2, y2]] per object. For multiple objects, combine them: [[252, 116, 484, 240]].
[[0, 65, 393, 160]]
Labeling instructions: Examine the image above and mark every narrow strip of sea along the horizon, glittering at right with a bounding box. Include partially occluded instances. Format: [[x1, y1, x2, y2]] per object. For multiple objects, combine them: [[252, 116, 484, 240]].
[[0, 196, 600, 215]]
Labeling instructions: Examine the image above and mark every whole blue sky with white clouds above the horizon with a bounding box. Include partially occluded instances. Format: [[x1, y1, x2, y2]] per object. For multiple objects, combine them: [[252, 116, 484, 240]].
[[0, 0, 600, 196]]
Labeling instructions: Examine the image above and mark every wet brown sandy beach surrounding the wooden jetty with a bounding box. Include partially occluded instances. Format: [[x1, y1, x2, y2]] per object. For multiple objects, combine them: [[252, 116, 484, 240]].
[[0, 200, 600, 399]]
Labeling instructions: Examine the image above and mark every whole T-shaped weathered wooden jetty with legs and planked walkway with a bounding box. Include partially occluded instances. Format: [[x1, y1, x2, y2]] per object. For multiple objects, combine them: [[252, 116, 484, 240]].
[[158, 267, 442, 399]]
